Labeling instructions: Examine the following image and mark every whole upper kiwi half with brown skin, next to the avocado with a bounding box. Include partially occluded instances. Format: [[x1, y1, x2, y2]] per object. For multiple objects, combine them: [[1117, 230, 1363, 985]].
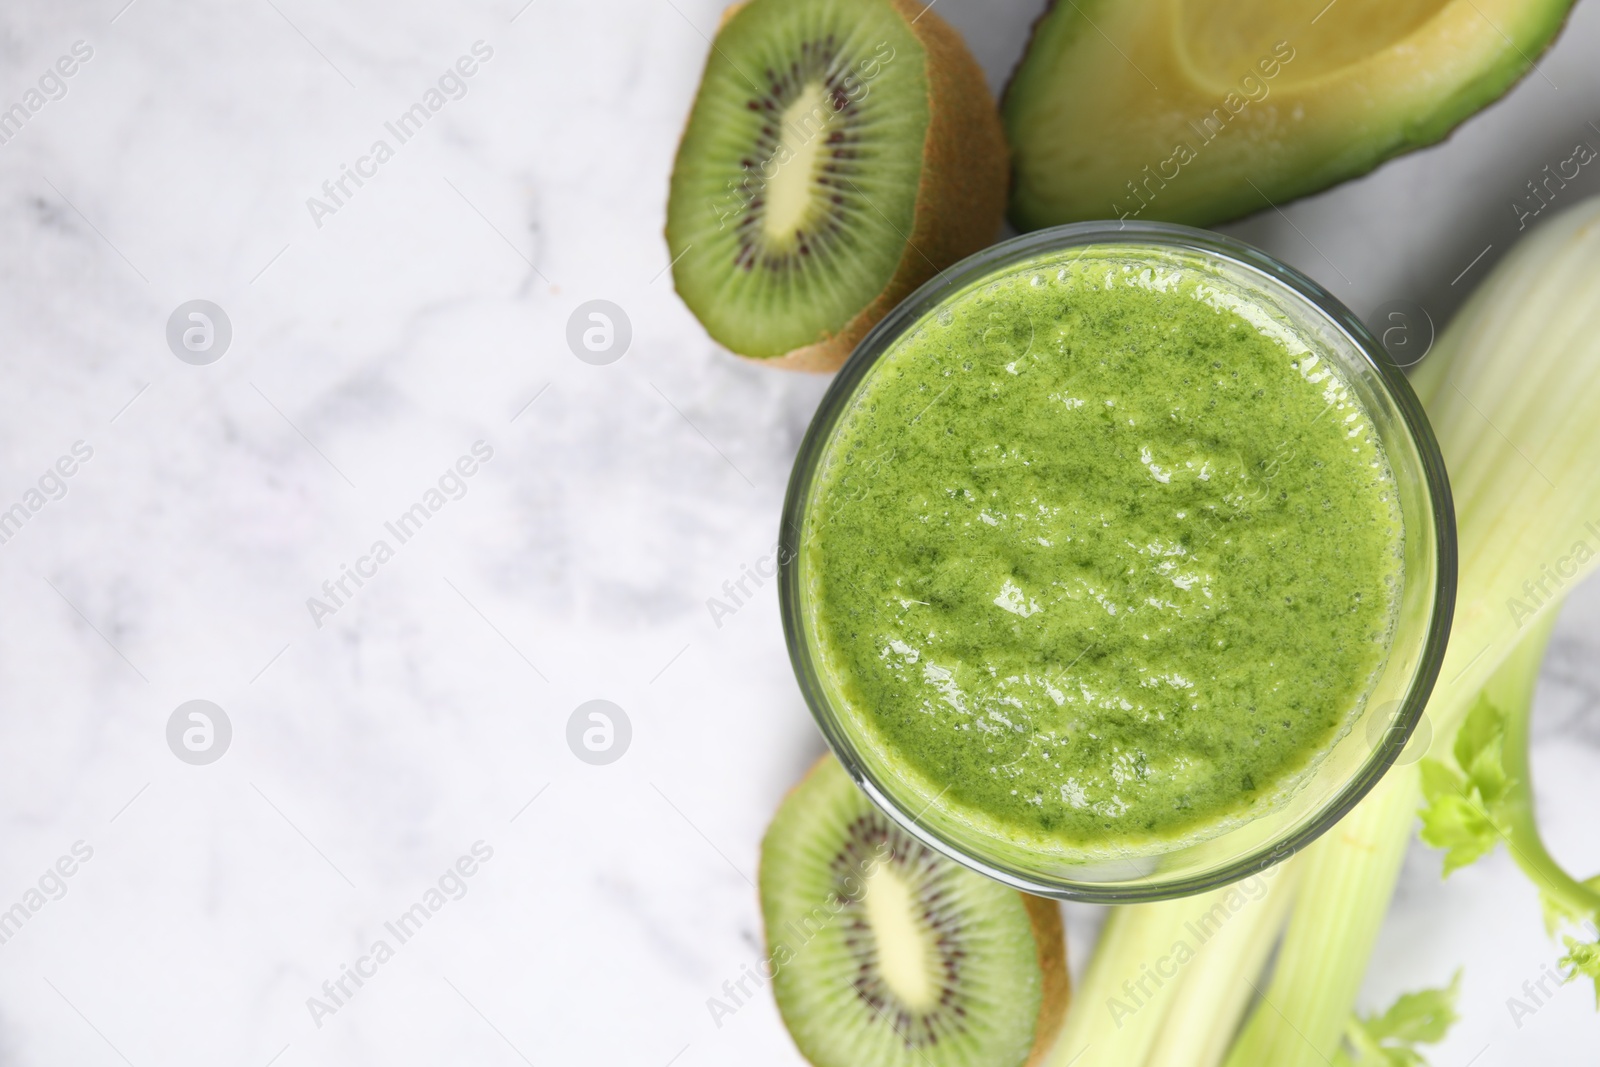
[[667, 0, 1010, 371]]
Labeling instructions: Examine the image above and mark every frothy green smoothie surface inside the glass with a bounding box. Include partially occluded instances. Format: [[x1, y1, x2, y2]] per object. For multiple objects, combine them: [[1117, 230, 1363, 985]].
[[800, 245, 1403, 849]]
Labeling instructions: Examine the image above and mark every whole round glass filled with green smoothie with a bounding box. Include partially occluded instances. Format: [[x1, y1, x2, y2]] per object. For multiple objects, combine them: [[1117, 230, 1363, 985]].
[[779, 224, 1456, 901]]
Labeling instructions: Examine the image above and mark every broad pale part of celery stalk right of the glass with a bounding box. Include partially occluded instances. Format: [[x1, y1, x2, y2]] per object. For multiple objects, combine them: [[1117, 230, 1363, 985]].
[[1413, 198, 1600, 713]]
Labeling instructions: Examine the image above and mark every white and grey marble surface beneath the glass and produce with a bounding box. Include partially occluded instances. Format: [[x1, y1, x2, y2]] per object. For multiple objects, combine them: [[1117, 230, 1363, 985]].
[[0, 0, 1600, 1067]]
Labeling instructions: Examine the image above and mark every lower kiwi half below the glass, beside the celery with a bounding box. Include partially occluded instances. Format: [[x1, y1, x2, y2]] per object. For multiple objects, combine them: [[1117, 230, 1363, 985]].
[[760, 757, 1067, 1067]]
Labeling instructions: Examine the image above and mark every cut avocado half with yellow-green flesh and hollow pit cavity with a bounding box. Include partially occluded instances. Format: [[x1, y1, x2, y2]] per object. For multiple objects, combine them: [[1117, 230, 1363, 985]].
[[1003, 0, 1573, 230]]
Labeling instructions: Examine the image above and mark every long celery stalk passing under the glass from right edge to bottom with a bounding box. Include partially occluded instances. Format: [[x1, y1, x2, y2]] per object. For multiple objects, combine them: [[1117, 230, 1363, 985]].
[[1229, 198, 1600, 1067]]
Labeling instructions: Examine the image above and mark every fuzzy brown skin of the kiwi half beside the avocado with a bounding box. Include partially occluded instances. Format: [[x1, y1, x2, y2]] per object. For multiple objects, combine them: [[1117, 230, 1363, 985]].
[[668, 0, 1011, 373]]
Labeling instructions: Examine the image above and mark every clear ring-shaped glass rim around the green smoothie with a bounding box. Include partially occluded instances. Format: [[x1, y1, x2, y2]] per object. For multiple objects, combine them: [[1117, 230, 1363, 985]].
[[778, 221, 1458, 904]]
